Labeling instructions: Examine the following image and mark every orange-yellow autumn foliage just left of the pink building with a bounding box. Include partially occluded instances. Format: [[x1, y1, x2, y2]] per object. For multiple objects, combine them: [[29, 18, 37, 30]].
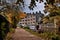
[[5, 11, 26, 24]]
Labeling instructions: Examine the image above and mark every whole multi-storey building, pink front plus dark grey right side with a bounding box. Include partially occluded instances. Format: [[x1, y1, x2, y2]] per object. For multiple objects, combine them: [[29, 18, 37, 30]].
[[19, 13, 42, 26]]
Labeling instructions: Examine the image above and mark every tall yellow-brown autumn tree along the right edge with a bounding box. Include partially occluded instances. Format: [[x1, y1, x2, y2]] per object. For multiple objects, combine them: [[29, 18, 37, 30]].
[[45, 0, 60, 32]]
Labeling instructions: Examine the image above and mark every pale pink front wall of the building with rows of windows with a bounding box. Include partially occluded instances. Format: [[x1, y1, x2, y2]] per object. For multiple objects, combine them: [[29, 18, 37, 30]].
[[19, 13, 36, 26]]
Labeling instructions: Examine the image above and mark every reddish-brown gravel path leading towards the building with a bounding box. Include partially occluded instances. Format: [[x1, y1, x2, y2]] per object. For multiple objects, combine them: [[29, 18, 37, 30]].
[[13, 28, 43, 40]]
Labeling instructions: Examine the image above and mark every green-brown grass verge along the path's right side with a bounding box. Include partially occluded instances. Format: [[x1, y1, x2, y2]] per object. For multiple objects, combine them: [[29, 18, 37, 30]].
[[25, 29, 58, 40]]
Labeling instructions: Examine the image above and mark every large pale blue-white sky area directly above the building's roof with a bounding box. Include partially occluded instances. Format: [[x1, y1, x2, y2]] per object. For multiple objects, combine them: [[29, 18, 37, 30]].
[[23, 0, 46, 13]]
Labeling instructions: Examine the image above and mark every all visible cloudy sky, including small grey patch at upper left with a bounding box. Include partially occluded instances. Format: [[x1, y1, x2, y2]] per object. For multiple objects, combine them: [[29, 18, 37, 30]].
[[0, 0, 48, 15]]
